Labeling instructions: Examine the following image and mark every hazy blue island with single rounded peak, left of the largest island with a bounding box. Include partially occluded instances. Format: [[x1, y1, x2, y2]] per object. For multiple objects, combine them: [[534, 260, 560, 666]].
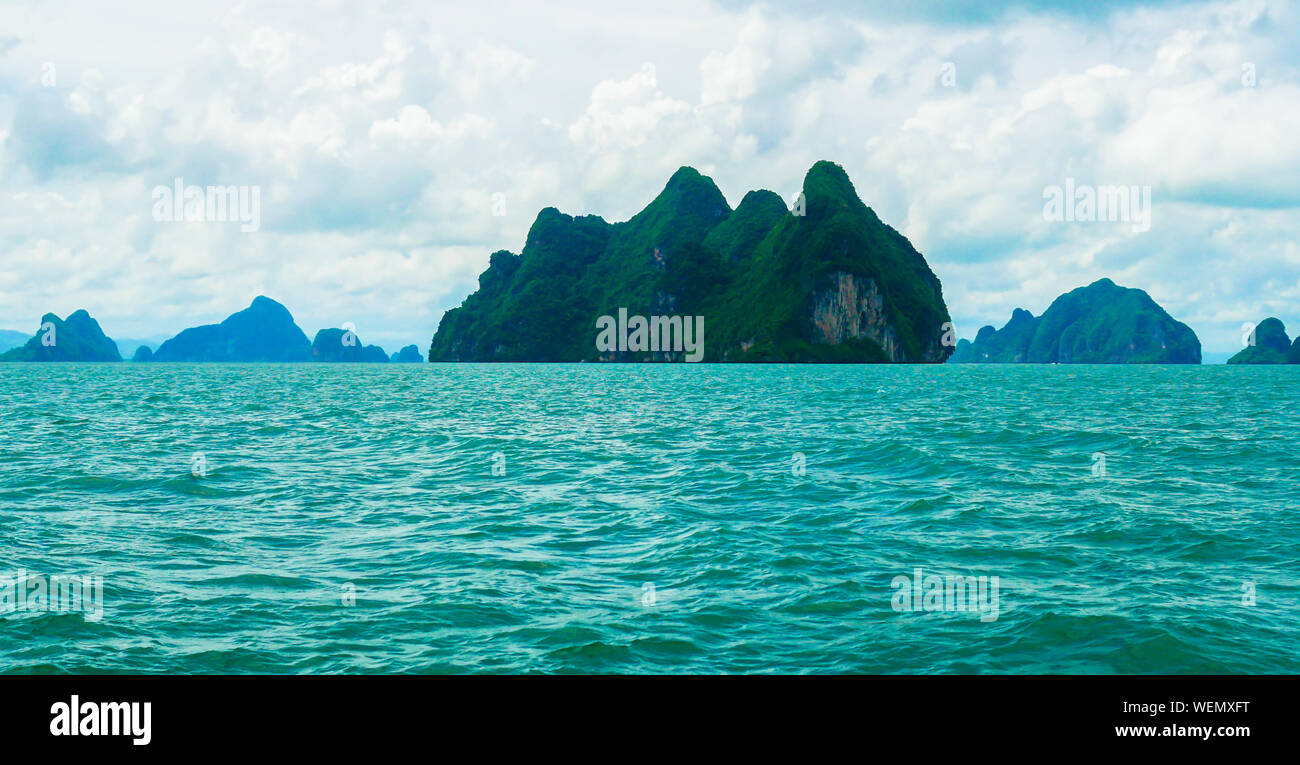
[[153, 297, 312, 362]]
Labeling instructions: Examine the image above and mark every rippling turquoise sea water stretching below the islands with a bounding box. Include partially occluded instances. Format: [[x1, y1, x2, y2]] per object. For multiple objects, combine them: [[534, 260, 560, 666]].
[[0, 364, 1300, 673]]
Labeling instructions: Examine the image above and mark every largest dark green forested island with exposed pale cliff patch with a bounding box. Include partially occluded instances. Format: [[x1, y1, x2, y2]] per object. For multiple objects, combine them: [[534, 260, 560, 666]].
[[429, 161, 952, 363]]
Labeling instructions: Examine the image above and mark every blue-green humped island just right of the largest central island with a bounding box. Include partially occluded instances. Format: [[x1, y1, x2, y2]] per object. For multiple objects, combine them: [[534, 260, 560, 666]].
[[952, 278, 1201, 364]]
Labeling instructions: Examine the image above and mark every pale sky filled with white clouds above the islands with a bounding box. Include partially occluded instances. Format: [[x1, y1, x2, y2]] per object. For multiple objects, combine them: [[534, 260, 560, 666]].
[[0, 0, 1300, 351]]
